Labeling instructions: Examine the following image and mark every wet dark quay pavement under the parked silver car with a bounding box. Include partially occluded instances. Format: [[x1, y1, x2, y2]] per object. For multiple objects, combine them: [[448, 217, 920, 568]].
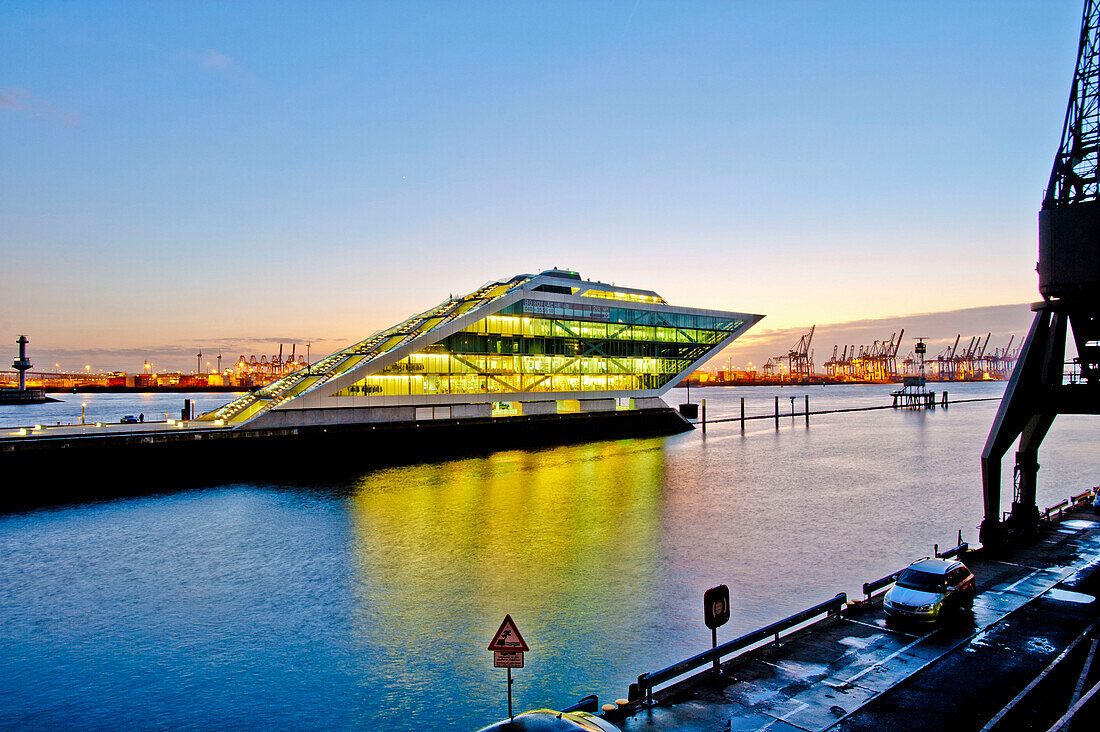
[[608, 514, 1100, 732]]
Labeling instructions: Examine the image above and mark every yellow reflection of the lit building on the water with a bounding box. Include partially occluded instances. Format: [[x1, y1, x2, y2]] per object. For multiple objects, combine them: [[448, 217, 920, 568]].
[[350, 439, 664, 665]]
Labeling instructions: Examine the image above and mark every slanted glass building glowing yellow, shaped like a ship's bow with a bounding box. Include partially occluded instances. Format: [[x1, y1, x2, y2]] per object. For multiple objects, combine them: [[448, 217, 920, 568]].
[[202, 270, 763, 426]]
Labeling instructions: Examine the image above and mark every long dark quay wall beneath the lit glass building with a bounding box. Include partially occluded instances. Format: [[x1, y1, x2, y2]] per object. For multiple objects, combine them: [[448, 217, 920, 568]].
[[0, 405, 693, 511]]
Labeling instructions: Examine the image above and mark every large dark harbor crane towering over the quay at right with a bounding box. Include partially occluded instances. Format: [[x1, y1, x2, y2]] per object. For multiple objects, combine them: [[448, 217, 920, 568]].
[[980, 0, 1100, 546]]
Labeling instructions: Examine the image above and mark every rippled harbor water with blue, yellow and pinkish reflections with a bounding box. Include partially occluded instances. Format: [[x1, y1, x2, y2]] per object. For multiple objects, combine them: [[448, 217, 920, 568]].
[[0, 383, 1100, 730]]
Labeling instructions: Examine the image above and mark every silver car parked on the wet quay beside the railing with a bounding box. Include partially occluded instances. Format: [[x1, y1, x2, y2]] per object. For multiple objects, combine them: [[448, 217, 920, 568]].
[[882, 559, 975, 623]]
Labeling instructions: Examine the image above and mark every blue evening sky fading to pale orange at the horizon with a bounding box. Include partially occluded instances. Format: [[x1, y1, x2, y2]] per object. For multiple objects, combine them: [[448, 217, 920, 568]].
[[0, 0, 1081, 371]]
